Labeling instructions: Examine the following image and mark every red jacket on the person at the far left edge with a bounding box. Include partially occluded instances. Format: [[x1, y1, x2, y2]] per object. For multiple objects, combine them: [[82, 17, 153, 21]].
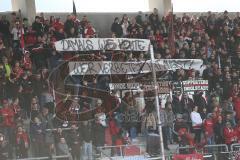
[[0, 107, 15, 127]]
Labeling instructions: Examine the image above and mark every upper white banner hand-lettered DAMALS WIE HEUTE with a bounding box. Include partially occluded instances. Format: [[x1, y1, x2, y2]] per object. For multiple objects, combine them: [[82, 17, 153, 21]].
[[55, 38, 150, 51]]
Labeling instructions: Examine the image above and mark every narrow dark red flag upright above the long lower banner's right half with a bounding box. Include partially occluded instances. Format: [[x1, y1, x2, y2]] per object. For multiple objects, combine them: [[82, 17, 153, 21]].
[[168, 3, 176, 57]]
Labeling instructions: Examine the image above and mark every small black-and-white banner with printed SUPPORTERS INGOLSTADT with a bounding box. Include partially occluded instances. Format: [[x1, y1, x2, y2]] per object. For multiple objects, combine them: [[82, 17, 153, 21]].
[[183, 80, 208, 92]]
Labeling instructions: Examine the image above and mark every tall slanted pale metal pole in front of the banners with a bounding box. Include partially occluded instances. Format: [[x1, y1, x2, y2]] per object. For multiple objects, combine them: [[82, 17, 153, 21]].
[[150, 45, 165, 160]]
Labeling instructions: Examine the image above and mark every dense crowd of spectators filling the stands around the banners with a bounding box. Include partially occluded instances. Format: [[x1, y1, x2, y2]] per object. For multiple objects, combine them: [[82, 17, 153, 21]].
[[0, 9, 240, 159]]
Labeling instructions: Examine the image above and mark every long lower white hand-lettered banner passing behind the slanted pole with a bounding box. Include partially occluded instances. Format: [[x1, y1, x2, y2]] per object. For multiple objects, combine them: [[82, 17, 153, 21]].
[[68, 59, 203, 75]]
